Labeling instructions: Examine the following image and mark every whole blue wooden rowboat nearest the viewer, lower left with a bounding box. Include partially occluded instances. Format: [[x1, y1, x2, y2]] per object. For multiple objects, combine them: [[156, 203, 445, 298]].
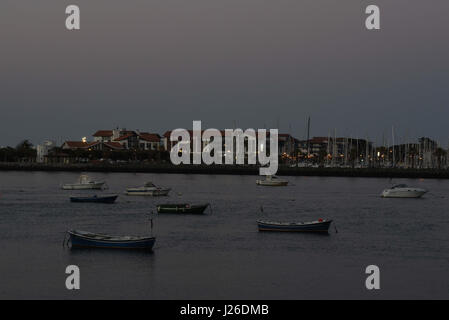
[[67, 230, 156, 250]]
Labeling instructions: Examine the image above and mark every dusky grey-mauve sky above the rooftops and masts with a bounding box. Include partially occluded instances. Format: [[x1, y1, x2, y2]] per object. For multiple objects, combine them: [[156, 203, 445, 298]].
[[0, 0, 449, 146]]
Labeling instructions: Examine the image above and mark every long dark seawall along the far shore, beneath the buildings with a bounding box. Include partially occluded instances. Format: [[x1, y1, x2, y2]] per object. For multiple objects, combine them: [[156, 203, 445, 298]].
[[0, 163, 449, 179]]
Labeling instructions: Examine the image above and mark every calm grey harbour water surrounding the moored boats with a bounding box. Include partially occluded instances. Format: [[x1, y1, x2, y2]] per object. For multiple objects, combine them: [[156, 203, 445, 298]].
[[0, 172, 449, 299]]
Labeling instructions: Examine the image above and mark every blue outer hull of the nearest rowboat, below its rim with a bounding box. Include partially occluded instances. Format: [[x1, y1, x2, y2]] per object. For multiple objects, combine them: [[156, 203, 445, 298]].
[[68, 231, 156, 250]]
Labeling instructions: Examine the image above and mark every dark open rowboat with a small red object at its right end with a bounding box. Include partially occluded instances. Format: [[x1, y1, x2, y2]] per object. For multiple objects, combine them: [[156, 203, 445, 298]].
[[257, 219, 332, 232]]
